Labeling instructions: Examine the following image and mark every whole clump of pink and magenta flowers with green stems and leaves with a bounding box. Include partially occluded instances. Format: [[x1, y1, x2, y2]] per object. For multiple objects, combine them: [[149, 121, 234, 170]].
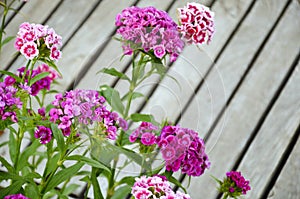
[[0, 3, 250, 199]]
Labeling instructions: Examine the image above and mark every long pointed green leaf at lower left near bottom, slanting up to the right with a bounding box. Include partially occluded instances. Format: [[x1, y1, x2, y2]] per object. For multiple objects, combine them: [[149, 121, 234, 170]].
[[45, 163, 84, 193]]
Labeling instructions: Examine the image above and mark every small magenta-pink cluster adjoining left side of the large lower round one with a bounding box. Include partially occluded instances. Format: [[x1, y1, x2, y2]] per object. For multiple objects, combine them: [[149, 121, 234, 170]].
[[129, 122, 158, 146]]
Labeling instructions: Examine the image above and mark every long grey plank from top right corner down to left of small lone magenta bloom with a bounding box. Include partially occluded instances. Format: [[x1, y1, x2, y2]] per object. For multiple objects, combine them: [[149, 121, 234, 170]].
[[185, 2, 300, 198]]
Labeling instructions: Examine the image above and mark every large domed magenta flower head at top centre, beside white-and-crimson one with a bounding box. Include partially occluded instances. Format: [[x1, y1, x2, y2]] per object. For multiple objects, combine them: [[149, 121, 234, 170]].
[[115, 6, 184, 62]]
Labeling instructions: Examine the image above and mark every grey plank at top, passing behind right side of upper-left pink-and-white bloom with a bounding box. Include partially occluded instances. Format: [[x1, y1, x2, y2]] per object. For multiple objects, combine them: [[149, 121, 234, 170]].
[[9, 0, 99, 72]]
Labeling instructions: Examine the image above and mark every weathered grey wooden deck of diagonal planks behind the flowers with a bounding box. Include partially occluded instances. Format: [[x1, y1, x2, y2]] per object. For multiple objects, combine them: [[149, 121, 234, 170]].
[[0, 0, 300, 199]]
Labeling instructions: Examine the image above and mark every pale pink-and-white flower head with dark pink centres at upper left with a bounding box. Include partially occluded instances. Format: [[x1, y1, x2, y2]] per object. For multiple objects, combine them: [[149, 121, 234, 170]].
[[15, 22, 62, 61]]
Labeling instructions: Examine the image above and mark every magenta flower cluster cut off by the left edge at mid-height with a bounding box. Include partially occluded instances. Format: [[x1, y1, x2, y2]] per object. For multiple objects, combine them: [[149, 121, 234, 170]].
[[0, 79, 22, 122]]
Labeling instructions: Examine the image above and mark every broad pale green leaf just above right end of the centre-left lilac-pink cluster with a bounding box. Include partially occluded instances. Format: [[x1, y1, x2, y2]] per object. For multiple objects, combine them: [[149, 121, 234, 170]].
[[100, 85, 124, 113]]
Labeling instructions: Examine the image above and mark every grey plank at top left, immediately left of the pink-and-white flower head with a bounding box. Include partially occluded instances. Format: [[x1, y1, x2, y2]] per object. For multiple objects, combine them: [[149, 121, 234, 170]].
[[0, 0, 60, 70]]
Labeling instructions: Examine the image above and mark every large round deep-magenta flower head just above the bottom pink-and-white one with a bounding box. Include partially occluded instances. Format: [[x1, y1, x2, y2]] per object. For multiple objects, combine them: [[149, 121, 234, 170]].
[[157, 126, 210, 176]]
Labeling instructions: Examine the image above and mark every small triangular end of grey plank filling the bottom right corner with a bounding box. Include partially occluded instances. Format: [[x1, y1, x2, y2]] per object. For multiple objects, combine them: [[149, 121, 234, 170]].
[[268, 134, 300, 199]]
